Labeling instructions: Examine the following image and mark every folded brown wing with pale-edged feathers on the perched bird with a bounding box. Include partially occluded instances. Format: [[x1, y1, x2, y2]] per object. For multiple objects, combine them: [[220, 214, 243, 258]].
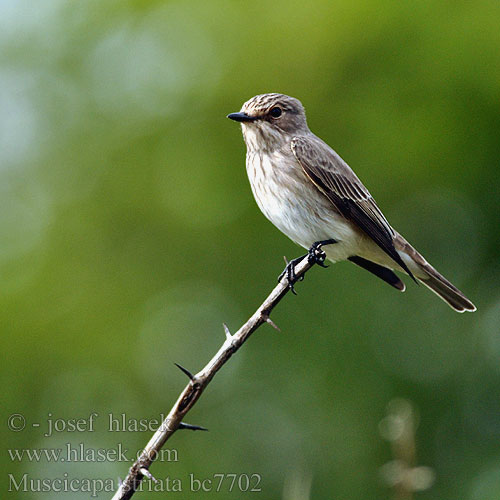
[[292, 136, 415, 279]]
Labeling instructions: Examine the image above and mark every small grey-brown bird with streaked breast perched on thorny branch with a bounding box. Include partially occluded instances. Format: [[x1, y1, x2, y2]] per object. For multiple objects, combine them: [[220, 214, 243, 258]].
[[227, 93, 476, 313]]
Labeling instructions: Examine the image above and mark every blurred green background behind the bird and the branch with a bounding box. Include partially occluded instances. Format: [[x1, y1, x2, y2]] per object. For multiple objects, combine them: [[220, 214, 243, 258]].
[[0, 0, 500, 500]]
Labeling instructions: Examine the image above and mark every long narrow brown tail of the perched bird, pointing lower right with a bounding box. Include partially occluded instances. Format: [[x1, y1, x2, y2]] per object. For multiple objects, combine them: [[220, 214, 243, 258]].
[[395, 235, 476, 313]]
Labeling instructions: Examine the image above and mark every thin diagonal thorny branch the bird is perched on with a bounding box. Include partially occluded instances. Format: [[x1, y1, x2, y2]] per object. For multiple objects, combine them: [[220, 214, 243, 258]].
[[112, 254, 318, 500]]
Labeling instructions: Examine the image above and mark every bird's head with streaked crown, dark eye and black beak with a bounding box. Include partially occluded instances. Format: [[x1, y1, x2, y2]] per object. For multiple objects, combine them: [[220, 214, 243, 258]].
[[227, 94, 309, 149]]
